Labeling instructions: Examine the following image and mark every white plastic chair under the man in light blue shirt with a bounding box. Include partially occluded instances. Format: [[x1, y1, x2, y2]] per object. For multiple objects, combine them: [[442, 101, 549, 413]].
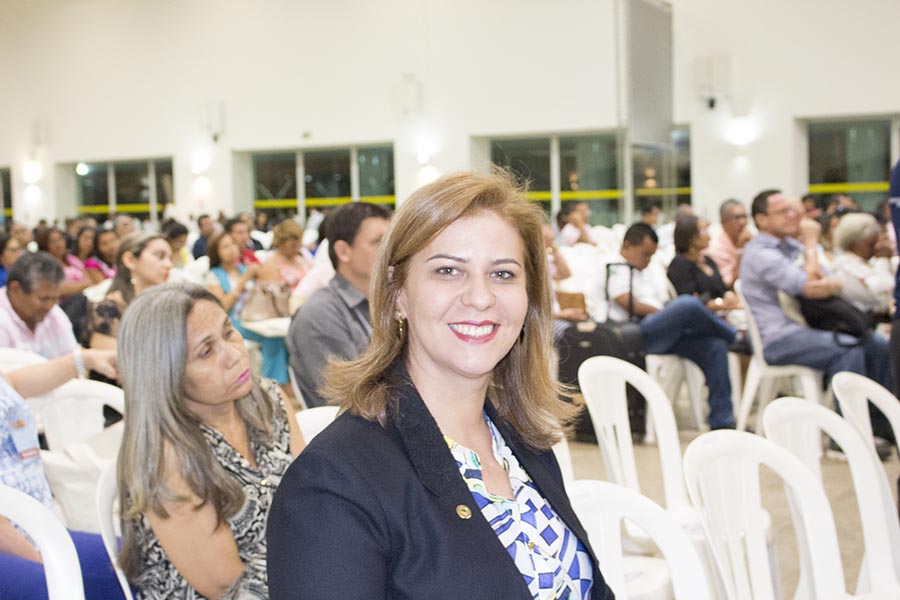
[[734, 280, 822, 434]]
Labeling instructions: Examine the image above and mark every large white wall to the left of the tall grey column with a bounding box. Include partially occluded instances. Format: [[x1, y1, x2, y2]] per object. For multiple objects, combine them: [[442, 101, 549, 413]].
[[0, 0, 617, 222]]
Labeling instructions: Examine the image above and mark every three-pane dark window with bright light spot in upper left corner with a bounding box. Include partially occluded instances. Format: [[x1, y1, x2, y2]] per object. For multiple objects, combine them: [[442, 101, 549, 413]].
[[75, 159, 175, 223]]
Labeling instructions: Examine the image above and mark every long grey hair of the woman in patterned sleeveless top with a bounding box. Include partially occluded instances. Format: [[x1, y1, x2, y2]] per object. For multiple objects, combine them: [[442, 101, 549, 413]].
[[116, 283, 275, 580]]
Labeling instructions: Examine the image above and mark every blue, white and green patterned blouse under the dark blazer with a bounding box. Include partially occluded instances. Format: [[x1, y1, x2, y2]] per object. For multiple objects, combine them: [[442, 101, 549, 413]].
[[444, 415, 593, 600]]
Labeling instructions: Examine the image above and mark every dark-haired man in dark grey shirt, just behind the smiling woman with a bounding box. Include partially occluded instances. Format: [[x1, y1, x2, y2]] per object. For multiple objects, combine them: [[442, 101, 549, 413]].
[[287, 202, 390, 406]]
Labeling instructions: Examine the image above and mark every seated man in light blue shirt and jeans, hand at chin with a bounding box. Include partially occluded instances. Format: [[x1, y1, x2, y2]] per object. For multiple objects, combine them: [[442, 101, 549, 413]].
[[741, 190, 891, 439]]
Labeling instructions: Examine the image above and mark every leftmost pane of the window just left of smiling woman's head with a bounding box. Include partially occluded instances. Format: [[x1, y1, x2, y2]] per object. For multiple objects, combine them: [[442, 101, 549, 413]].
[[253, 152, 297, 220]]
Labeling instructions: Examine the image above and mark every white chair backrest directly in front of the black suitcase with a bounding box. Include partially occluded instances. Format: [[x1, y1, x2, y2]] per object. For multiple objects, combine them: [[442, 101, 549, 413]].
[[578, 356, 689, 508]]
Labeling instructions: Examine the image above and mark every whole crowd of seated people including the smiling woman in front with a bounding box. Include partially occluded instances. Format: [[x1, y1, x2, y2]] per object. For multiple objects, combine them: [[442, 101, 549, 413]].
[[0, 168, 894, 598]]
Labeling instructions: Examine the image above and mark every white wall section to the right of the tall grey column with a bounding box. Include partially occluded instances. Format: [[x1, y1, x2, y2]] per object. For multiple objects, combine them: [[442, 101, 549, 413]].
[[673, 0, 900, 215]]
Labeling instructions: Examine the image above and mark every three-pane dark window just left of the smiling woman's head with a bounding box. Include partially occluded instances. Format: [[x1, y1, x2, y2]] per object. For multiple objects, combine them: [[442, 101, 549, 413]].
[[252, 146, 395, 221]]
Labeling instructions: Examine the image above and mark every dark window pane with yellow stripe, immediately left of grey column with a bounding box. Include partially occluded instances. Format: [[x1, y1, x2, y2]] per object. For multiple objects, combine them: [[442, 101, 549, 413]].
[[559, 135, 621, 226]]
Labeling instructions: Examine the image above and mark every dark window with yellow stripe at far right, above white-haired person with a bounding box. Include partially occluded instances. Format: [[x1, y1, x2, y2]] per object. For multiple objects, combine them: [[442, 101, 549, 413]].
[[808, 119, 891, 211]]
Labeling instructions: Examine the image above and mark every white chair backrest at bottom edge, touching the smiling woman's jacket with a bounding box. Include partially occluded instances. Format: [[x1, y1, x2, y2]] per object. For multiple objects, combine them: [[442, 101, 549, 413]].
[[568, 480, 713, 600]]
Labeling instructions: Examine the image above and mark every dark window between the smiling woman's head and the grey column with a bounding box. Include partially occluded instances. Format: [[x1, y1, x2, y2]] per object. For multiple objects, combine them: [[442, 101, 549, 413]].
[[490, 134, 623, 226]]
